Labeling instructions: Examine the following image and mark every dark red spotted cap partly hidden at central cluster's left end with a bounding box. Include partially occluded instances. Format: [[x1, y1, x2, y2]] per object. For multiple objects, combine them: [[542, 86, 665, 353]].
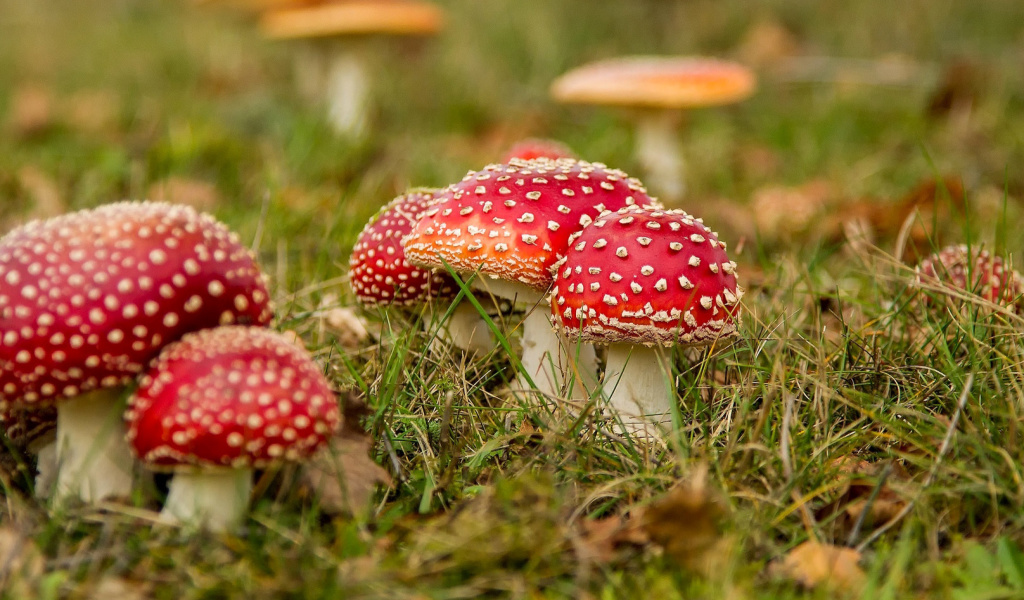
[[348, 189, 457, 306]]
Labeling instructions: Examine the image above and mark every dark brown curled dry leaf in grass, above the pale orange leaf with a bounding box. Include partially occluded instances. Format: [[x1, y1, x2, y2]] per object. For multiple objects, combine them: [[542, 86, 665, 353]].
[[817, 457, 907, 537]]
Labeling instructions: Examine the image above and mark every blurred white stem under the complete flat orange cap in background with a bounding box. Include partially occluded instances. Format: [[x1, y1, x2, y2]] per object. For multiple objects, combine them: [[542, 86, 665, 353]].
[[636, 110, 686, 202]]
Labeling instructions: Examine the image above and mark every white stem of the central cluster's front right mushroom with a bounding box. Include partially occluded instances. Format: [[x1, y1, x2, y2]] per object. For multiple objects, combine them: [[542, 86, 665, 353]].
[[603, 344, 676, 436]]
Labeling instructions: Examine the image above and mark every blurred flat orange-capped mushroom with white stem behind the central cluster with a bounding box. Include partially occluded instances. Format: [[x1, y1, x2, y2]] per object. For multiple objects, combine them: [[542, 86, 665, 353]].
[[551, 56, 756, 201]]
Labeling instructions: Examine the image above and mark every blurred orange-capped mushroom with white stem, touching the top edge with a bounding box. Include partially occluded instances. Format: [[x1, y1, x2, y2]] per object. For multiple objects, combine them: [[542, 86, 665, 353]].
[[262, 0, 443, 138]]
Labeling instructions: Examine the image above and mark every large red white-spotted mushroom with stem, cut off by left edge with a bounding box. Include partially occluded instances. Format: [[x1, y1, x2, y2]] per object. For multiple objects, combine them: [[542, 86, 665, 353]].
[[0, 202, 271, 502]]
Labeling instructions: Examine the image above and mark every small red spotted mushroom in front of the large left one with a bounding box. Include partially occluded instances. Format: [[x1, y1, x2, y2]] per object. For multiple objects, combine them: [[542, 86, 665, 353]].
[[125, 326, 341, 530]]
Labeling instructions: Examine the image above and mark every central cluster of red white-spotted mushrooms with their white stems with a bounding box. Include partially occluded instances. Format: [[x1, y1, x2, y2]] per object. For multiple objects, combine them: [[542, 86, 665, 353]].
[[350, 145, 742, 437]]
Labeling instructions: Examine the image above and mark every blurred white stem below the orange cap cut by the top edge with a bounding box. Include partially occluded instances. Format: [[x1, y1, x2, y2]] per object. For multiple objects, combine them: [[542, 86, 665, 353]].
[[325, 42, 370, 138]]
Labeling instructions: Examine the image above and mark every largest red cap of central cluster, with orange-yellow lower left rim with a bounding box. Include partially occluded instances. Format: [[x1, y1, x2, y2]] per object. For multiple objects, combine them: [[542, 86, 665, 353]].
[[403, 159, 657, 290]]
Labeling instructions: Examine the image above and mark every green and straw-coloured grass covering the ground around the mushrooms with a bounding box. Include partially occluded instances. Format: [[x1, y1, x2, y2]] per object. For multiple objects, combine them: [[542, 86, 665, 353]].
[[0, 0, 1024, 600]]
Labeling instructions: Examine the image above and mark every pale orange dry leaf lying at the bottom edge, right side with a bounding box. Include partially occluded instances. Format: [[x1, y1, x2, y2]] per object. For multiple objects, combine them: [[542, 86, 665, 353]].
[[770, 541, 865, 595]]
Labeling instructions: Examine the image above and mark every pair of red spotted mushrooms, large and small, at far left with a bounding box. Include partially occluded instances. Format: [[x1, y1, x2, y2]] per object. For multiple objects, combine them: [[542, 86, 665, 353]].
[[0, 202, 341, 529]]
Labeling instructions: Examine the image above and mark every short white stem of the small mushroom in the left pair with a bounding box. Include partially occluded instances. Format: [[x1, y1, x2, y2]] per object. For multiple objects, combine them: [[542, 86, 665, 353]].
[[160, 469, 253, 531]]
